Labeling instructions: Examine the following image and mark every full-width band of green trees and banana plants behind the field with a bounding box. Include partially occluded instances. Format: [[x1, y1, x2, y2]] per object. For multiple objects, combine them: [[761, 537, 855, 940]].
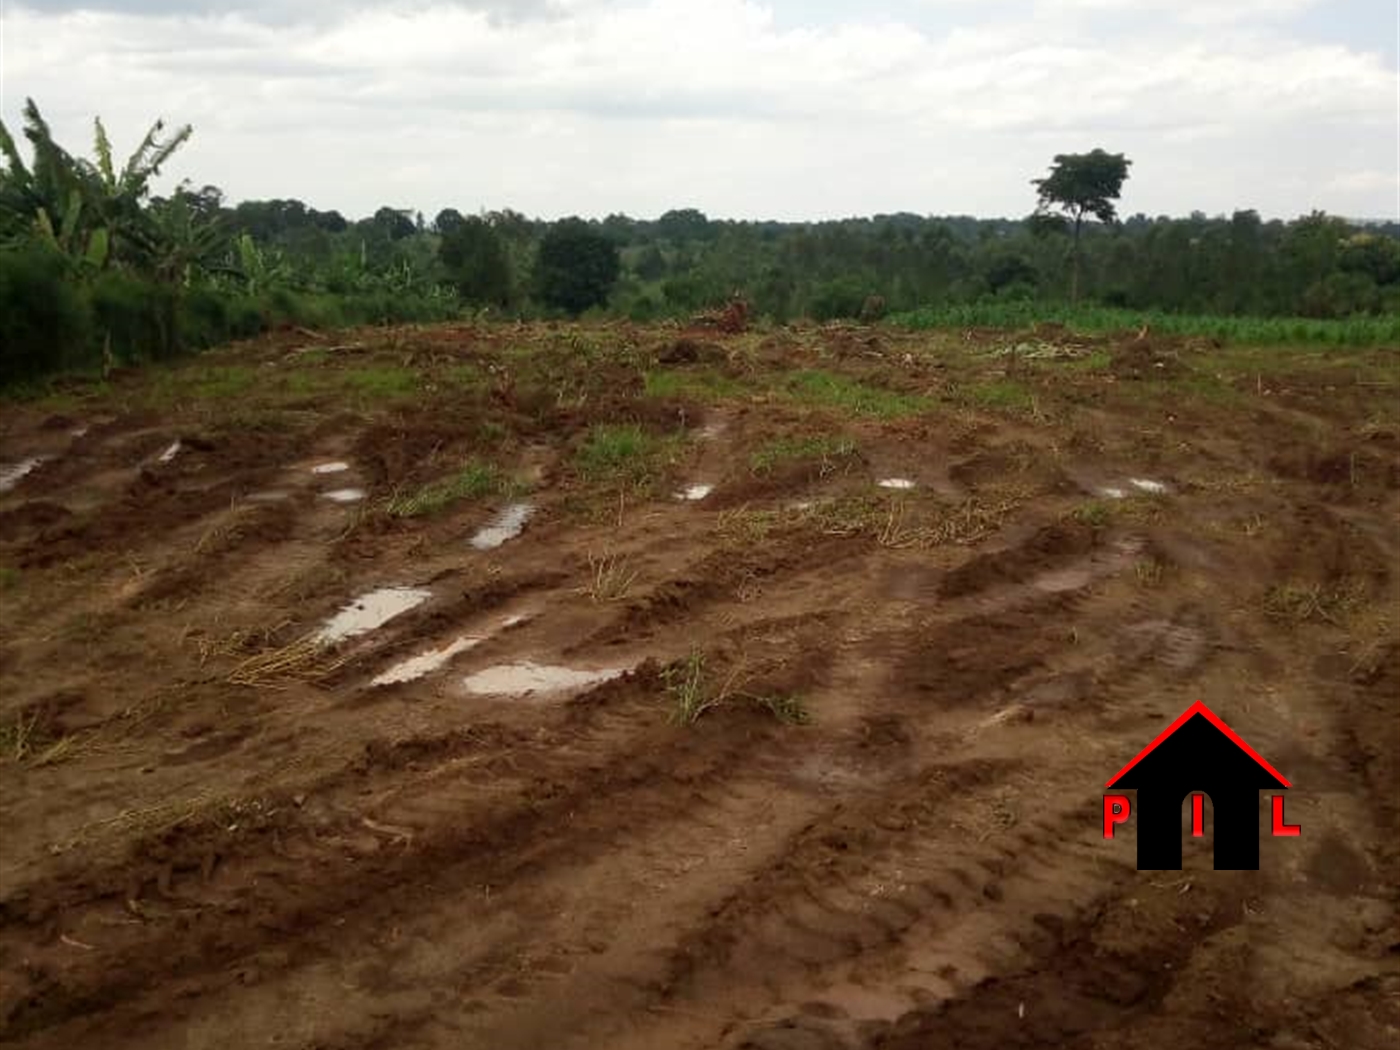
[[0, 102, 1400, 382]]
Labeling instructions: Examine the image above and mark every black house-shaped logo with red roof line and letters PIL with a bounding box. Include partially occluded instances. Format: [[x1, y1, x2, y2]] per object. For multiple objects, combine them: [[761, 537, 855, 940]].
[[1103, 703, 1301, 871]]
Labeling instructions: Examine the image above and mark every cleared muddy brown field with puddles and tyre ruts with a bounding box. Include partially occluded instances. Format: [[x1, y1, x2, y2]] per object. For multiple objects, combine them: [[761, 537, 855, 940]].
[[0, 326, 1400, 1050]]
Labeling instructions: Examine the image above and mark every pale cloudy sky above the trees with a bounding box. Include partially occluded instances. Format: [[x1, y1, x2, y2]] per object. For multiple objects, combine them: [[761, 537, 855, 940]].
[[0, 0, 1400, 220]]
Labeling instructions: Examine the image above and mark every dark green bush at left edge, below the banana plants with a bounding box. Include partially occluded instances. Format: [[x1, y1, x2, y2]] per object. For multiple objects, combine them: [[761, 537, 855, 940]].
[[0, 249, 88, 384]]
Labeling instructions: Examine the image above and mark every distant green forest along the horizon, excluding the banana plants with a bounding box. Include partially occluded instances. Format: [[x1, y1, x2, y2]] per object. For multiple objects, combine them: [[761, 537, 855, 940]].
[[228, 202, 1400, 322]]
